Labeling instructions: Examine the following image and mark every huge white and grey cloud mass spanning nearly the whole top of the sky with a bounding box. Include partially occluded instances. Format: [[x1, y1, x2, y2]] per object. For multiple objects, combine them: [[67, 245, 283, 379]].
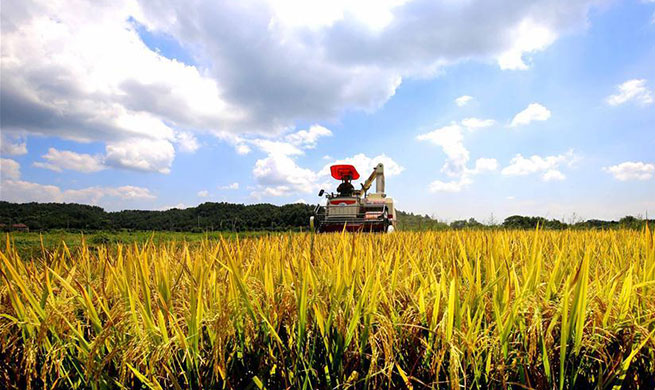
[[0, 0, 592, 166]]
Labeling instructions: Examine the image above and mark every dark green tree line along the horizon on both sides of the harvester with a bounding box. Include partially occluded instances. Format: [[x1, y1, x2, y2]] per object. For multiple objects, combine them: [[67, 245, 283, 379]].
[[0, 201, 655, 232]]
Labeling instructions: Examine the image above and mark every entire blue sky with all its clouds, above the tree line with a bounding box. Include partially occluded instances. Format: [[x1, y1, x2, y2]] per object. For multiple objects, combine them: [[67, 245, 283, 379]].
[[0, 0, 655, 221]]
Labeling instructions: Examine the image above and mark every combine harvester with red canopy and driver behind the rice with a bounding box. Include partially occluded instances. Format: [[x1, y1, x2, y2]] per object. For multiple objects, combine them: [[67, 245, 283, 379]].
[[309, 163, 396, 233]]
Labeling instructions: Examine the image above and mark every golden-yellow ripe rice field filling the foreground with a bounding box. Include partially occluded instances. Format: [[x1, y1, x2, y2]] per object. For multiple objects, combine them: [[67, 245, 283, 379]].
[[0, 229, 655, 389]]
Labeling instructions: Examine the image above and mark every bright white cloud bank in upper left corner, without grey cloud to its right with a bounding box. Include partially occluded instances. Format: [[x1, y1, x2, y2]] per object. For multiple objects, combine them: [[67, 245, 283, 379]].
[[1, 1, 240, 172]]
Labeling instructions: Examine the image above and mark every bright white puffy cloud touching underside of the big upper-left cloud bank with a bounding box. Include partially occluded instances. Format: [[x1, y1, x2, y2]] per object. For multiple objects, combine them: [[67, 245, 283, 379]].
[[105, 138, 175, 173]]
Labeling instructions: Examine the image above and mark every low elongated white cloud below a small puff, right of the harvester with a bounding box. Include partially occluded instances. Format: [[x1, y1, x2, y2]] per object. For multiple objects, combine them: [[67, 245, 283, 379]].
[[500, 150, 577, 181]]
